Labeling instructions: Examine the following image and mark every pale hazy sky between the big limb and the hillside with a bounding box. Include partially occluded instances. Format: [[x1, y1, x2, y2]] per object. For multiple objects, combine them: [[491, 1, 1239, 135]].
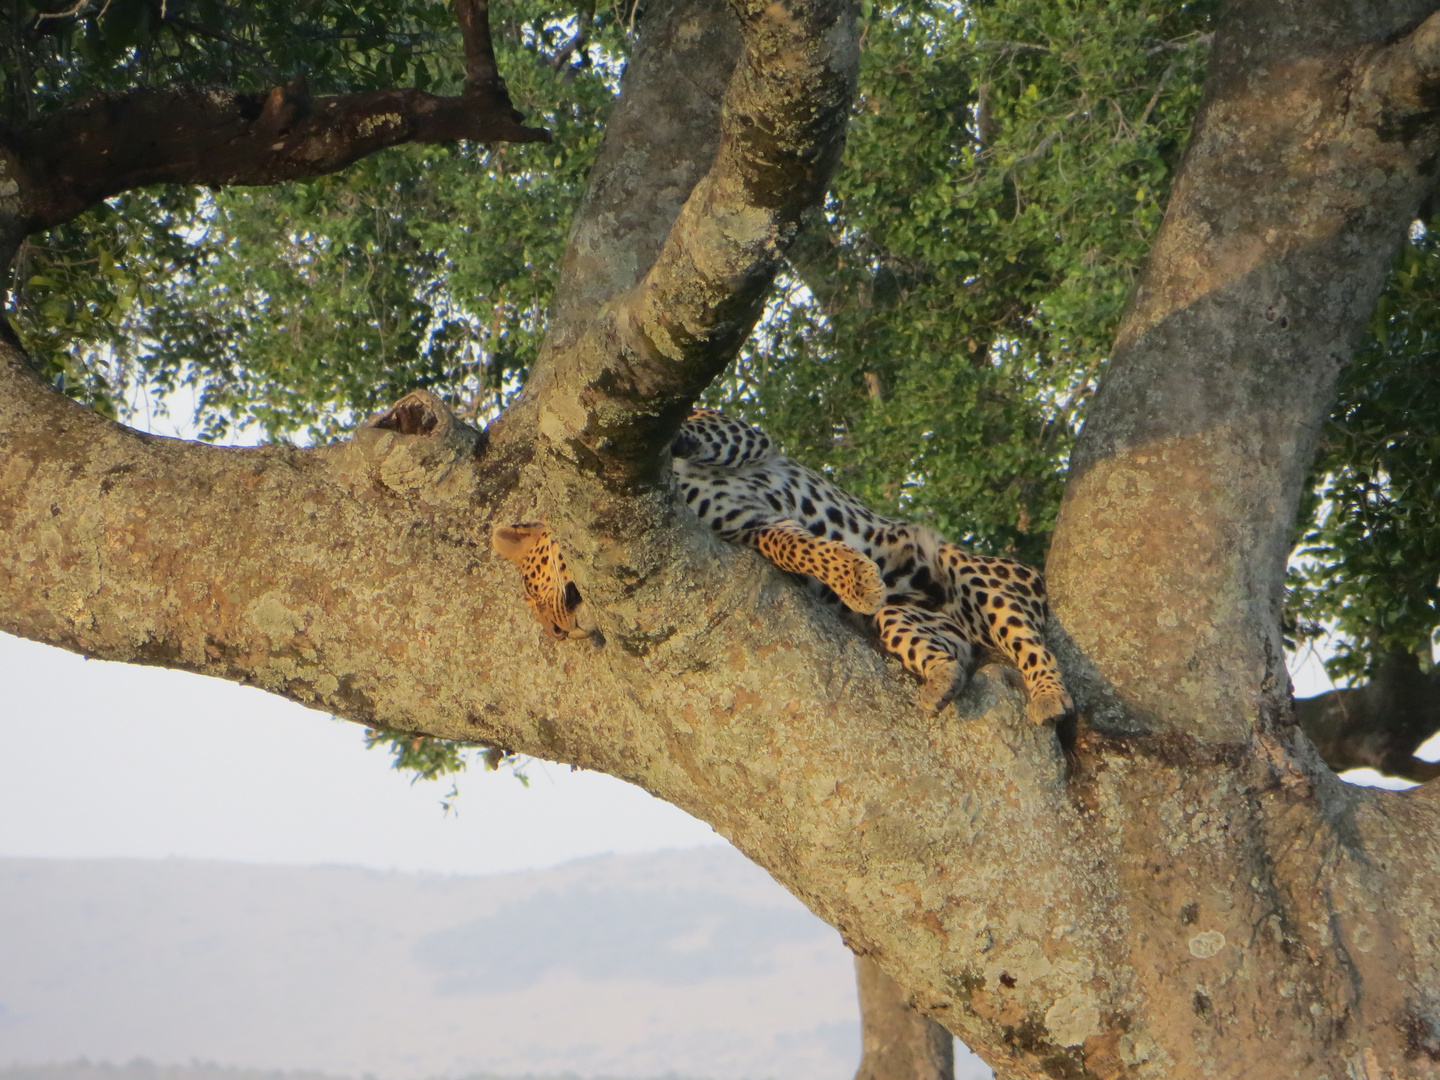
[[0, 634, 724, 874]]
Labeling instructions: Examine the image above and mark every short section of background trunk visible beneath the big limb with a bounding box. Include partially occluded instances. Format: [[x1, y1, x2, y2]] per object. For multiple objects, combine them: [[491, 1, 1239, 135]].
[[855, 956, 955, 1080]]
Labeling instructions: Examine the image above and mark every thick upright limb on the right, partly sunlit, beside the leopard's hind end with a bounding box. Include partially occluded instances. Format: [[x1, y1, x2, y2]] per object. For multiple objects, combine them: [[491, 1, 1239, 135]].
[[1048, 0, 1440, 742]]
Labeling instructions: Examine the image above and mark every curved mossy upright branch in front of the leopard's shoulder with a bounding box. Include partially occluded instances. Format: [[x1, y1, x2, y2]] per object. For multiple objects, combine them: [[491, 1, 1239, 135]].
[[537, 0, 858, 490]]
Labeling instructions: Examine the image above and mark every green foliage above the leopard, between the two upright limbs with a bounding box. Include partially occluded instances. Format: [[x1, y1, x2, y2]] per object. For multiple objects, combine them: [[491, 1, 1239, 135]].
[[710, 0, 1211, 563]]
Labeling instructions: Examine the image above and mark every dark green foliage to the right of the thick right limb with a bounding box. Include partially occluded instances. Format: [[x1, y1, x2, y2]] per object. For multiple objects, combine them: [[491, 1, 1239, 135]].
[[1287, 229, 1440, 683]]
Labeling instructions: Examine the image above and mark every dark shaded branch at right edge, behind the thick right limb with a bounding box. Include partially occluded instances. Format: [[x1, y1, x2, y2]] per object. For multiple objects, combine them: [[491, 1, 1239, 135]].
[[1295, 652, 1440, 783]]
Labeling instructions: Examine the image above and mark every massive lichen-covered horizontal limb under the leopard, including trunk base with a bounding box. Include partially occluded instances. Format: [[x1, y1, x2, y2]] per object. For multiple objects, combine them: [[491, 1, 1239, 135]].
[[8, 344, 1440, 1080]]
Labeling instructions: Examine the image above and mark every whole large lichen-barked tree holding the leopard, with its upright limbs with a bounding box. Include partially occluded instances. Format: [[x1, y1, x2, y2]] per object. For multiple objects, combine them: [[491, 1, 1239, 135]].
[[0, 1, 1440, 1077]]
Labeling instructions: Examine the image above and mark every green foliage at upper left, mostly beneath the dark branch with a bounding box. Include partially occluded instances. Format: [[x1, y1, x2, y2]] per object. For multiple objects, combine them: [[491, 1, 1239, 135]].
[[14, 0, 624, 441]]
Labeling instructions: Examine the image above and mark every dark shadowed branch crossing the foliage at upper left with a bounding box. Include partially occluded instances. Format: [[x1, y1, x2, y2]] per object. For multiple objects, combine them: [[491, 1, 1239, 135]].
[[0, 82, 549, 232]]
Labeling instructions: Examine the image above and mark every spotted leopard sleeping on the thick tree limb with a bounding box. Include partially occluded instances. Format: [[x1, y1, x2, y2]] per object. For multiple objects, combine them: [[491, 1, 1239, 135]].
[[491, 409, 1073, 723]]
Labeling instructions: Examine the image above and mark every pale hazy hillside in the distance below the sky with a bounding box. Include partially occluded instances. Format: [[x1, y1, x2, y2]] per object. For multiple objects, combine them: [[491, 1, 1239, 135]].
[[0, 847, 988, 1080]]
